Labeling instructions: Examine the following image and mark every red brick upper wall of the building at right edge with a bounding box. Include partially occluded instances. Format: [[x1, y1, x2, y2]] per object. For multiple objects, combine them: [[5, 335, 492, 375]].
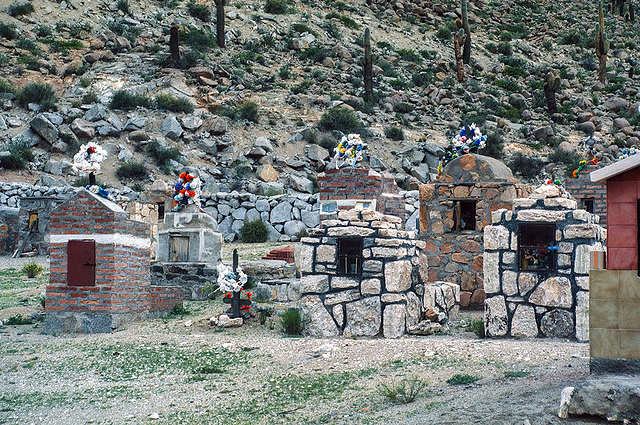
[[607, 168, 640, 270]]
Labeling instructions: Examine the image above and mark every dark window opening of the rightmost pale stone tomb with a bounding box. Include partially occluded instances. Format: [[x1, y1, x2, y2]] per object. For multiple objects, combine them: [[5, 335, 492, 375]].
[[518, 224, 558, 272]]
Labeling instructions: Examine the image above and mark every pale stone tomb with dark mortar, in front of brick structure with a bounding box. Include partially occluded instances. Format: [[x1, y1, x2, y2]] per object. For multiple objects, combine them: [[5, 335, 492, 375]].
[[296, 209, 459, 338]]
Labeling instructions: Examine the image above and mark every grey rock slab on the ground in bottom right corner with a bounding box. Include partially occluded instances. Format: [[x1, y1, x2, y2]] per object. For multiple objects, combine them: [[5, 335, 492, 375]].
[[558, 375, 640, 423]]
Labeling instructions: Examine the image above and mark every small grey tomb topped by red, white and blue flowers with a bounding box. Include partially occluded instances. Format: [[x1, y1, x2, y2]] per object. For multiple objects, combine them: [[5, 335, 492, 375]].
[[151, 205, 222, 300]]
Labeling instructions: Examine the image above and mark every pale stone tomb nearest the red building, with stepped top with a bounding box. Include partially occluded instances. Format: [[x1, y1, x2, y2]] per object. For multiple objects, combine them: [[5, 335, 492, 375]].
[[484, 184, 605, 341]]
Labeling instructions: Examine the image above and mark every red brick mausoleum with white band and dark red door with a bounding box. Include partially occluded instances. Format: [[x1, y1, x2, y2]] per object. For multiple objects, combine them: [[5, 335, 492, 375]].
[[45, 190, 183, 334]]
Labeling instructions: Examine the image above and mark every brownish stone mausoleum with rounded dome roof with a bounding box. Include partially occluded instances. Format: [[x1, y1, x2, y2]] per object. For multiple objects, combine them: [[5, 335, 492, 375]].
[[419, 154, 526, 308]]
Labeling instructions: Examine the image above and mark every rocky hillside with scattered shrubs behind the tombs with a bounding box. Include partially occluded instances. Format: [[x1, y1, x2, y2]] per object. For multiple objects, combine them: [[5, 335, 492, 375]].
[[0, 0, 640, 197]]
